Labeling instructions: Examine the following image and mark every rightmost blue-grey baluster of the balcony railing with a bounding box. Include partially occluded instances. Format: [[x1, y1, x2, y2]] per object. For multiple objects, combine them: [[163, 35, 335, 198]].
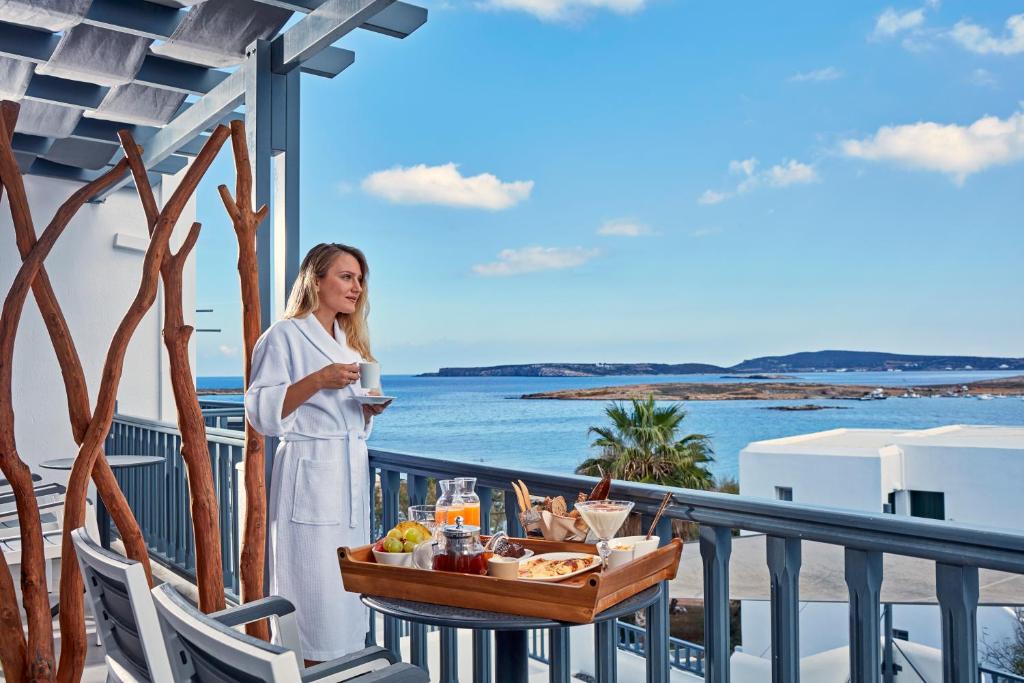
[[935, 562, 978, 683]]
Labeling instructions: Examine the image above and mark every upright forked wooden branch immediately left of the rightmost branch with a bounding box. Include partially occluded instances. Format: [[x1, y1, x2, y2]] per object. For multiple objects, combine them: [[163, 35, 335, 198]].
[[119, 131, 224, 612]]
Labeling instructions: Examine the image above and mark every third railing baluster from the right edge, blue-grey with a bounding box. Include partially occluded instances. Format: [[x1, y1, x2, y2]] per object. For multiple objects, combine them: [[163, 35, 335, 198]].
[[767, 536, 800, 683]]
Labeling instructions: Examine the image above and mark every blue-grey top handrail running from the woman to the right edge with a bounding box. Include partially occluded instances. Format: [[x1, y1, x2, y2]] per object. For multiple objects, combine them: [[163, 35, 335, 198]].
[[370, 449, 1024, 573]]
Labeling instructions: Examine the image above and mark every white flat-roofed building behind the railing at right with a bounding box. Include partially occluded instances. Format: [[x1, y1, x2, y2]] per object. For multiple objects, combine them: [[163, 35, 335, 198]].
[[739, 425, 1024, 657]]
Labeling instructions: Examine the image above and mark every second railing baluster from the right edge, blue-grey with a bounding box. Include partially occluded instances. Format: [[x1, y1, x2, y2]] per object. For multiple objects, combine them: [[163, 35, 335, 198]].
[[846, 548, 882, 683]]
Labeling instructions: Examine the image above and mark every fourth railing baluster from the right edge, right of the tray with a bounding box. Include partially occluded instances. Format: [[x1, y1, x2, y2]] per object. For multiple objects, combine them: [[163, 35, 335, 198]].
[[700, 524, 732, 683]]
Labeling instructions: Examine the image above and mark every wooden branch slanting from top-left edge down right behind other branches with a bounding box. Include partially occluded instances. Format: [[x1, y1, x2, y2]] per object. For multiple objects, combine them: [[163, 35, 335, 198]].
[[0, 101, 153, 586]]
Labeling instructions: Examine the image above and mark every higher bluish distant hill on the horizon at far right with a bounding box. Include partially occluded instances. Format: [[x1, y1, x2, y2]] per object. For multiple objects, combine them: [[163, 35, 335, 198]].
[[730, 351, 1024, 373]]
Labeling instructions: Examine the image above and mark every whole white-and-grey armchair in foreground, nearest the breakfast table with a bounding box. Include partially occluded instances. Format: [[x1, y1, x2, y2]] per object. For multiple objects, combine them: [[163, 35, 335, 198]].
[[153, 584, 428, 683]]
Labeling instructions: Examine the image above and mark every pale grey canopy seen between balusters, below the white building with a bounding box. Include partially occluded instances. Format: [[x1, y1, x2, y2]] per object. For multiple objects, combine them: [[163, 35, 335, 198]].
[[669, 535, 1024, 606]]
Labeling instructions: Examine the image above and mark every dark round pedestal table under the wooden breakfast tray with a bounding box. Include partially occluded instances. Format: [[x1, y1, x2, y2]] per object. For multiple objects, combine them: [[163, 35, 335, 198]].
[[360, 584, 664, 683]]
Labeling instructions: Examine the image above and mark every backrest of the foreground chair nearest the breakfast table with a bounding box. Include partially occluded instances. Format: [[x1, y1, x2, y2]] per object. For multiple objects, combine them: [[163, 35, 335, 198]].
[[153, 584, 302, 683]]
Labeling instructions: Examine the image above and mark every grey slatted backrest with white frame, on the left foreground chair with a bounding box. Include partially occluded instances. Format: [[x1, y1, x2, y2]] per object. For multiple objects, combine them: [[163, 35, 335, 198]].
[[71, 528, 175, 683]]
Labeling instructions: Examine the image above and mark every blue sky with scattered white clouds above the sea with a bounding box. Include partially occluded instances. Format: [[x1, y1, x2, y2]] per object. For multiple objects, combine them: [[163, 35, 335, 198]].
[[197, 0, 1024, 375]]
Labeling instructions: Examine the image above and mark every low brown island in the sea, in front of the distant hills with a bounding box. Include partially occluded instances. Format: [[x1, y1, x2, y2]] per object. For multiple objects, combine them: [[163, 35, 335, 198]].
[[520, 375, 1024, 401]]
